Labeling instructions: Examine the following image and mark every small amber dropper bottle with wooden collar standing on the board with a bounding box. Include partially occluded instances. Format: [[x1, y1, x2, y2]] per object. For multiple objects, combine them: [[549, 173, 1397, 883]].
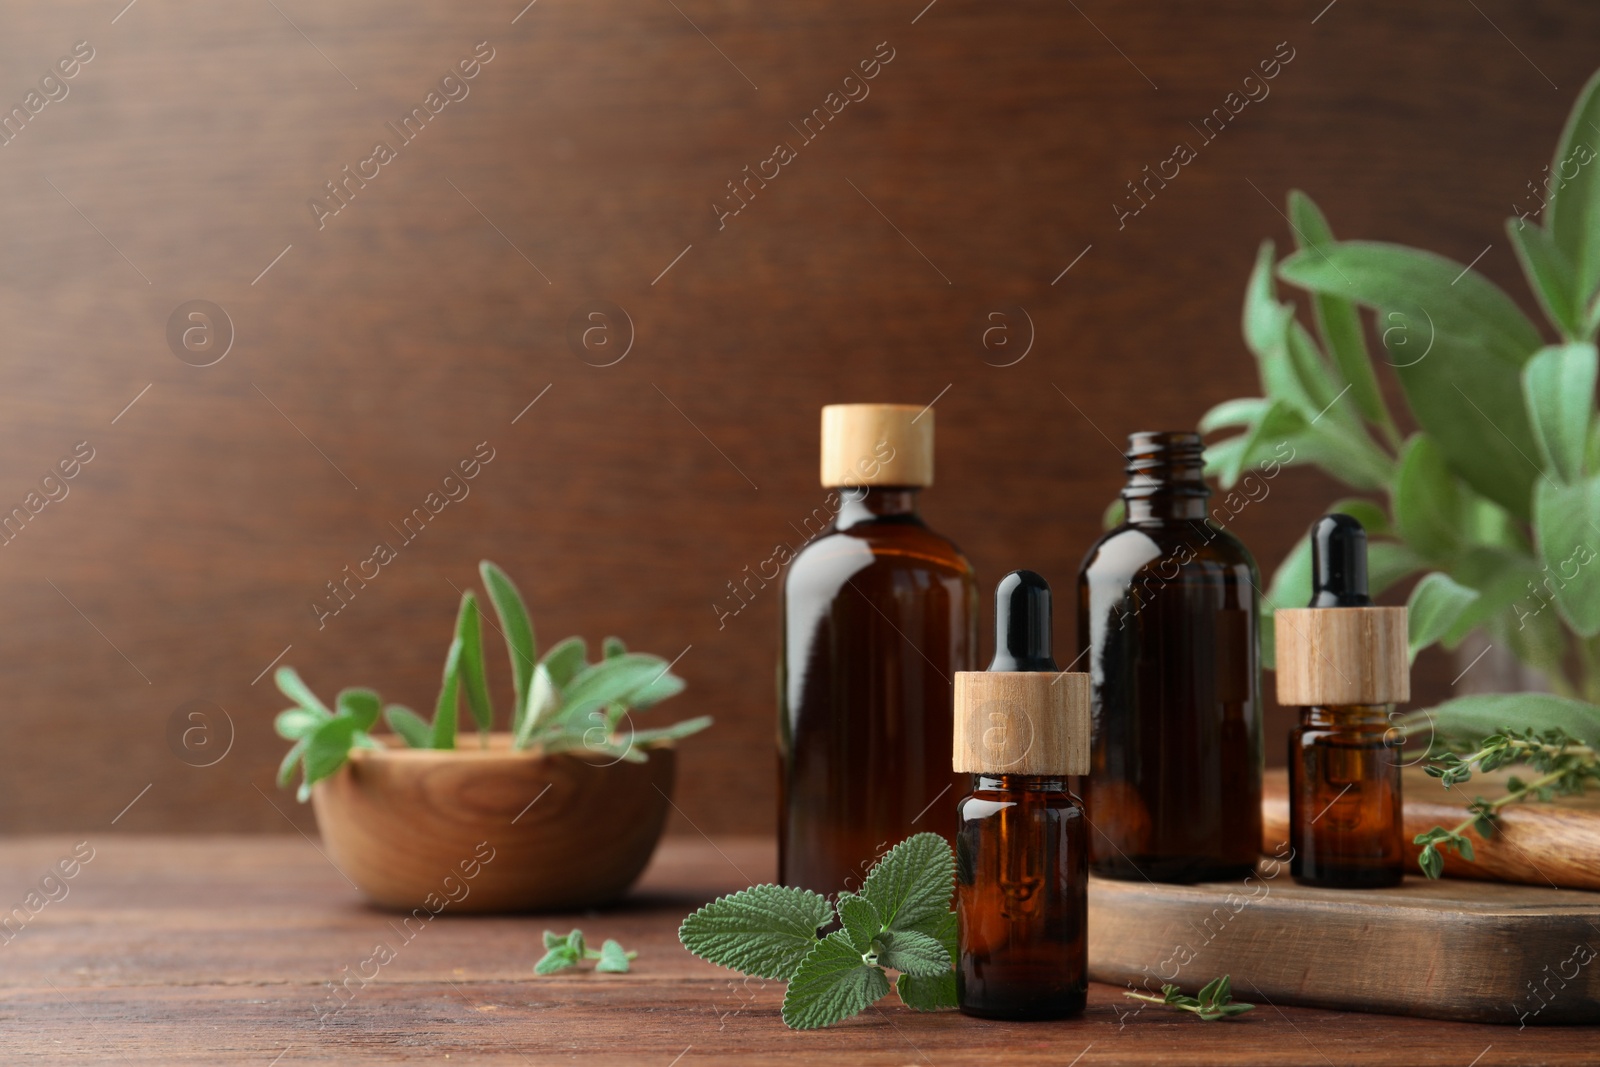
[[1274, 514, 1411, 889]]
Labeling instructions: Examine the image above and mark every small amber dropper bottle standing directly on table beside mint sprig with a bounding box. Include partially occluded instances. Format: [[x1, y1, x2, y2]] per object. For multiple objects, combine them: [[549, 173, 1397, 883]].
[[954, 571, 1090, 1019]]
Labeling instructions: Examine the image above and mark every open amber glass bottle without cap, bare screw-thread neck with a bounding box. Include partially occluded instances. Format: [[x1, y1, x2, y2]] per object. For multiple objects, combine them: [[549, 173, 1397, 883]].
[[1078, 432, 1262, 881]]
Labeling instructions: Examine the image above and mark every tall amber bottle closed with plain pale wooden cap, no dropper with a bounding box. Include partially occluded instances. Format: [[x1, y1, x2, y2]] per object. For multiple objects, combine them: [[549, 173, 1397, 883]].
[[778, 403, 978, 894]]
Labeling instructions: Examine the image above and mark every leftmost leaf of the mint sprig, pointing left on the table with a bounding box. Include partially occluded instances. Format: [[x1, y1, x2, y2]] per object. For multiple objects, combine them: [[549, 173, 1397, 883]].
[[678, 885, 832, 981]]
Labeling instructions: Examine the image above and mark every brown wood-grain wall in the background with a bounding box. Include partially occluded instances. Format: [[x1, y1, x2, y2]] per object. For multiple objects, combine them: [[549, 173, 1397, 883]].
[[0, 0, 1600, 832]]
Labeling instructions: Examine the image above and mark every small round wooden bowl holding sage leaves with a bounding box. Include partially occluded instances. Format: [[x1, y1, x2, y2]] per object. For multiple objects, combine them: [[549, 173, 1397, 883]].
[[312, 734, 677, 913]]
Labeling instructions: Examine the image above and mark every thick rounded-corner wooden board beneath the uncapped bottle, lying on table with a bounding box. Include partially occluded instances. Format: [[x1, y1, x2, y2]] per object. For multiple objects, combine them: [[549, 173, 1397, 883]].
[[1088, 853, 1600, 1027]]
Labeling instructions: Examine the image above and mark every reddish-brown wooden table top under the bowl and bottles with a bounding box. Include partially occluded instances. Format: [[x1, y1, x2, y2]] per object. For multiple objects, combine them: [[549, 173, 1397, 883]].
[[0, 835, 1600, 1067]]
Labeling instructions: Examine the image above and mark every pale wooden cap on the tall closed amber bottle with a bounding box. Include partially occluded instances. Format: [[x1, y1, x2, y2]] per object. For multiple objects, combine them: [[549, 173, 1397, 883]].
[[822, 403, 933, 490]]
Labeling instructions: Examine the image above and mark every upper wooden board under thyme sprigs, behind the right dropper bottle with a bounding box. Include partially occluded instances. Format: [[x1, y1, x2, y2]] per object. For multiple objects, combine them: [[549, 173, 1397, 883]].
[[1261, 768, 1600, 895]]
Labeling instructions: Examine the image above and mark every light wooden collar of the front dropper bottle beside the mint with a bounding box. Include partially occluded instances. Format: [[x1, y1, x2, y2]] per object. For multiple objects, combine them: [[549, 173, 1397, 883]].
[[950, 670, 1090, 774]]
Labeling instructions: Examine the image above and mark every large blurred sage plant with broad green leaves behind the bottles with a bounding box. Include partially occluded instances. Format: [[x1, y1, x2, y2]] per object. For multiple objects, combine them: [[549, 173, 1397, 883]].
[[1200, 66, 1600, 873]]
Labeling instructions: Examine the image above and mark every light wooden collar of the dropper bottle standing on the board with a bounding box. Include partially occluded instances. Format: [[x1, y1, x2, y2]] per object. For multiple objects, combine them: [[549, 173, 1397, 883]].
[[1274, 608, 1411, 707]]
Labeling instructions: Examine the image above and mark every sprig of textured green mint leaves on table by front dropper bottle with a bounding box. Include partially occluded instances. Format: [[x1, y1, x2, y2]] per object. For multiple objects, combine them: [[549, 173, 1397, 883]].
[[678, 833, 955, 1030]]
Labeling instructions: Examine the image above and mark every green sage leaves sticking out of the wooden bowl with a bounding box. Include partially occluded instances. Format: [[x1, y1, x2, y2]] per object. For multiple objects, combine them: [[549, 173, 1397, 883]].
[[274, 560, 710, 801]]
